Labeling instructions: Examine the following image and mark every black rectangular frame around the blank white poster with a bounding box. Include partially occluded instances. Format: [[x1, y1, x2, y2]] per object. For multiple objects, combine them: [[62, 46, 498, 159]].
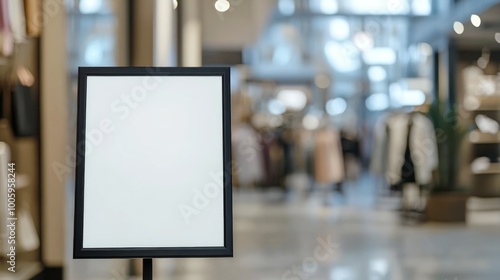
[[73, 67, 233, 259]]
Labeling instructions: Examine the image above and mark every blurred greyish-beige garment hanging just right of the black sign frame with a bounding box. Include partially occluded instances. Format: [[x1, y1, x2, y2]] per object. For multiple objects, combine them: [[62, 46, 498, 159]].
[[233, 123, 264, 186]]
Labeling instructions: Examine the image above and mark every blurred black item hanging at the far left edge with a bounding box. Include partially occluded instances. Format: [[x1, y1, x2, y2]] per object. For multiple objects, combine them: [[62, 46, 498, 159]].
[[12, 85, 37, 137]]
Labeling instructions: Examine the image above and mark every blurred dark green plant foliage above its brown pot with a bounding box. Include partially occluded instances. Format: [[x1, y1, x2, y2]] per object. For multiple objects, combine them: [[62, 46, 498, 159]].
[[428, 100, 469, 192]]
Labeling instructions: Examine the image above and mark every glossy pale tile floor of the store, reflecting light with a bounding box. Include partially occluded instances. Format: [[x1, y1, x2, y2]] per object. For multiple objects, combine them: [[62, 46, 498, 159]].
[[66, 176, 500, 280]]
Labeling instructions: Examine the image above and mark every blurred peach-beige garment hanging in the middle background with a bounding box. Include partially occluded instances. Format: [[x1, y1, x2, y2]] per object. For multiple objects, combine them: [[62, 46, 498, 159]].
[[314, 128, 344, 184]]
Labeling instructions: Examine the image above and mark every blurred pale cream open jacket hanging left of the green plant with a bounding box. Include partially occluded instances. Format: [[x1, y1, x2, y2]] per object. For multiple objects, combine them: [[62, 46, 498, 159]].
[[386, 113, 438, 185]]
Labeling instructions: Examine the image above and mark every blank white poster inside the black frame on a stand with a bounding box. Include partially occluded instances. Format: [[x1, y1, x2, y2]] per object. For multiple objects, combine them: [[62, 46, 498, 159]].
[[83, 76, 224, 248]]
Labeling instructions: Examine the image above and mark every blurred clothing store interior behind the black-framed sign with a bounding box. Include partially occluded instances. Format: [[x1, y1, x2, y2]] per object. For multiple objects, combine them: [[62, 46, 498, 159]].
[[0, 0, 500, 280]]
